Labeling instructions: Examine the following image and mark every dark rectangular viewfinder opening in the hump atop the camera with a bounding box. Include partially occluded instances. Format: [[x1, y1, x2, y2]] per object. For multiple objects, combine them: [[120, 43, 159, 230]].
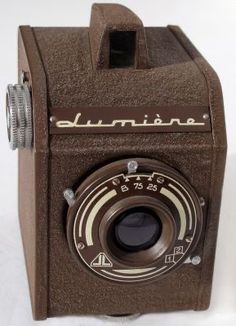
[[109, 31, 136, 68]]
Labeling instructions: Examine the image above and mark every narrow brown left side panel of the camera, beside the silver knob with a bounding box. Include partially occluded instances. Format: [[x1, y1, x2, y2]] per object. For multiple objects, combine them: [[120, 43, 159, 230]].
[[18, 26, 48, 319]]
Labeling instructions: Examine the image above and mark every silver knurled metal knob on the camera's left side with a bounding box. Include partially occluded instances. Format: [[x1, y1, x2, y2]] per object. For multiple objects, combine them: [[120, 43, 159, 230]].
[[6, 84, 33, 150]]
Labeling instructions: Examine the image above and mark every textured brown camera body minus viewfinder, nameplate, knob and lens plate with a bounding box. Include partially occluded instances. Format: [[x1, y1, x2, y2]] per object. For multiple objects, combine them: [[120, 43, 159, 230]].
[[19, 5, 226, 319]]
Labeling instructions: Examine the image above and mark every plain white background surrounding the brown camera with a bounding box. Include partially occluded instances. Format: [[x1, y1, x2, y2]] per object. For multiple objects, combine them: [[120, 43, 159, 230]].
[[0, 0, 236, 326]]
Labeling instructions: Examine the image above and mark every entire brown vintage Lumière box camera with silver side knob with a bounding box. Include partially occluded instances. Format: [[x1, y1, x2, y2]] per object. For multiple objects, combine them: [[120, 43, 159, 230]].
[[7, 4, 226, 319]]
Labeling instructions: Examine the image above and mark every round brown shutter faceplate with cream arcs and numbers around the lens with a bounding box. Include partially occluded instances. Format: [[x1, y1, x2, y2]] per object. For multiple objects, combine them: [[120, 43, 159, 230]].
[[67, 159, 202, 282]]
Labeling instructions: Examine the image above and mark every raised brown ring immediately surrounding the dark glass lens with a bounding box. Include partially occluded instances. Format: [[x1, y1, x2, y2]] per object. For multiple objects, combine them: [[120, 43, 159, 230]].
[[99, 196, 176, 268]]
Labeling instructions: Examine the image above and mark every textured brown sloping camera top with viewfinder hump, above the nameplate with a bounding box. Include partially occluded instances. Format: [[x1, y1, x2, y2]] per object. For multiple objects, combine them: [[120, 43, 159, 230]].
[[30, 5, 209, 109]]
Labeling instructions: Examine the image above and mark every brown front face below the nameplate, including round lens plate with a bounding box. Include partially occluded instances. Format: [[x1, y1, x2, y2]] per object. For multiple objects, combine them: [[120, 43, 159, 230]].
[[49, 134, 212, 314]]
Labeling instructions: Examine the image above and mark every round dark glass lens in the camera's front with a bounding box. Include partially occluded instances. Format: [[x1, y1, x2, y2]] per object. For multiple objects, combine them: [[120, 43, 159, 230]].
[[114, 207, 162, 252]]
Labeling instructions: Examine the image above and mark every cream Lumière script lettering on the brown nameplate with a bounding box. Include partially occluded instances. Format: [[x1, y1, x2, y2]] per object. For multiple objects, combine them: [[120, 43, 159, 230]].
[[55, 112, 205, 128]]
